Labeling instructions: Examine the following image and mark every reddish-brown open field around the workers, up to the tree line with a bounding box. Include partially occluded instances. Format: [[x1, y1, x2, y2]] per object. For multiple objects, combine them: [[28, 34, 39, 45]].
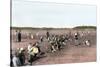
[[10, 28, 96, 65]]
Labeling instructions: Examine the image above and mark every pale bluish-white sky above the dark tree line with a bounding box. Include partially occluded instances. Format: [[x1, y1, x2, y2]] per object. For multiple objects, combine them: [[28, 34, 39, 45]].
[[12, 0, 96, 28]]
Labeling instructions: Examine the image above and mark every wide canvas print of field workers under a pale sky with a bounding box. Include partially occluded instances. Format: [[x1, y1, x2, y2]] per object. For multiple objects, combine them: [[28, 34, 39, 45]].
[[10, 0, 97, 67]]
